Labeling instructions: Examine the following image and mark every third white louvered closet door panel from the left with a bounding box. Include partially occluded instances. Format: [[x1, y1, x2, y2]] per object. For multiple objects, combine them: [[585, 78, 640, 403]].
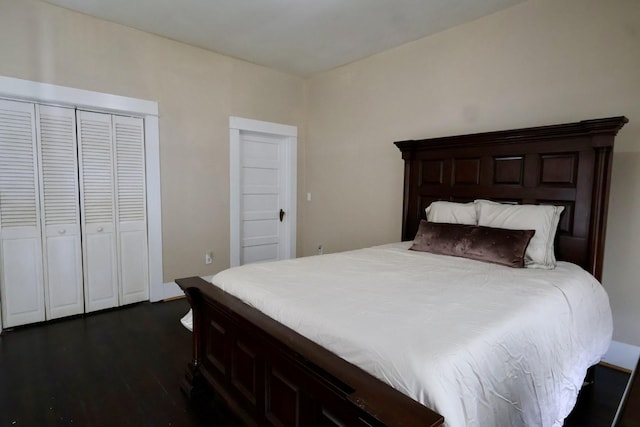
[[77, 111, 118, 312]]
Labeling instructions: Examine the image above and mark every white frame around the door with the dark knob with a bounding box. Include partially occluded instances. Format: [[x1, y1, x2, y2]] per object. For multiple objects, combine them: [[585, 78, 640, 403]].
[[229, 116, 298, 267]]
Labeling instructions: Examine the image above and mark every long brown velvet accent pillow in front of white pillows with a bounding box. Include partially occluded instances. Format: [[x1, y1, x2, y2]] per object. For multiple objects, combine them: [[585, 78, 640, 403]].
[[409, 220, 535, 268]]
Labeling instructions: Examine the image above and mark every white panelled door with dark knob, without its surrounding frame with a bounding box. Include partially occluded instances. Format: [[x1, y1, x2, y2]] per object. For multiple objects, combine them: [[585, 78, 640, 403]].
[[240, 132, 289, 264]]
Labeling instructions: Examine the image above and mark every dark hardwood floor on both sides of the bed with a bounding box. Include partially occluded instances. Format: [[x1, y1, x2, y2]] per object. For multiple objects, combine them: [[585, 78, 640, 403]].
[[0, 300, 629, 427]]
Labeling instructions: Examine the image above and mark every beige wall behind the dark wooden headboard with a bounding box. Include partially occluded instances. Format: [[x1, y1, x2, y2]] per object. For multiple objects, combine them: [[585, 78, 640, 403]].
[[303, 0, 640, 345]]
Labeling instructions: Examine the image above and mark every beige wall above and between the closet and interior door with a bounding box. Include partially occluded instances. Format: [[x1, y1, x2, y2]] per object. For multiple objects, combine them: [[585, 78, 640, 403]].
[[0, 0, 304, 282]]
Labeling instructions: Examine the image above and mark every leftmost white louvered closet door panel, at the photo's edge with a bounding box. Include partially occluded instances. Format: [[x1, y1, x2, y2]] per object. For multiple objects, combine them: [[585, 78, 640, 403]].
[[0, 100, 45, 327]]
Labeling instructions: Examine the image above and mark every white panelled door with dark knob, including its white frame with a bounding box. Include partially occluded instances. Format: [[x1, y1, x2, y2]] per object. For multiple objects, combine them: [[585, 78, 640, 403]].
[[231, 118, 297, 265]]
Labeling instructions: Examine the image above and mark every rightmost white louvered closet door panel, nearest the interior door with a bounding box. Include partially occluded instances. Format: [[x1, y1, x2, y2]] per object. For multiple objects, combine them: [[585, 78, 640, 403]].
[[113, 116, 149, 305]]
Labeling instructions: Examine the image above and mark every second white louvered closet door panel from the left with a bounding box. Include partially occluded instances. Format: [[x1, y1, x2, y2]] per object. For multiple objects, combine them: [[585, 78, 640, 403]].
[[36, 105, 84, 319]]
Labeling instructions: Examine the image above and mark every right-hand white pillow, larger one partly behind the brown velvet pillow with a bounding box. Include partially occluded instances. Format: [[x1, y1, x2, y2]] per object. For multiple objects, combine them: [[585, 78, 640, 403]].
[[475, 200, 564, 269]]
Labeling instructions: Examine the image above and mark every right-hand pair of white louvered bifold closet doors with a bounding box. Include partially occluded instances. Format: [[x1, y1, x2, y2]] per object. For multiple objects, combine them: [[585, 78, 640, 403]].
[[77, 111, 149, 311]]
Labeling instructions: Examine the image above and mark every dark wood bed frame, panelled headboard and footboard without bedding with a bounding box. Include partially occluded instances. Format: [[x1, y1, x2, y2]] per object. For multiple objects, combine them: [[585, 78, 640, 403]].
[[176, 117, 627, 427]]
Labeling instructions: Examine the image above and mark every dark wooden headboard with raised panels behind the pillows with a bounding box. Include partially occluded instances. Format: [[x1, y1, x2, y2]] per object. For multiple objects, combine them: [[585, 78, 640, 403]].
[[395, 117, 628, 280]]
